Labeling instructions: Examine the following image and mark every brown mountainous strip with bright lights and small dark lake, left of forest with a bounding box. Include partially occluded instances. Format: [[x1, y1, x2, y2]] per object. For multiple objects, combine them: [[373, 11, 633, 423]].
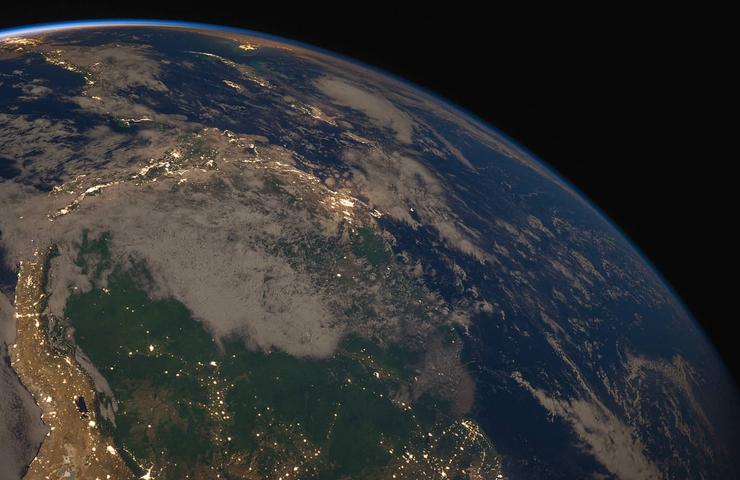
[[10, 251, 134, 480]]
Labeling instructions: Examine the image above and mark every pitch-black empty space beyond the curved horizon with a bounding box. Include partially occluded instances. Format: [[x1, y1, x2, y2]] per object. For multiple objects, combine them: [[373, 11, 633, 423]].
[[0, 1, 739, 378]]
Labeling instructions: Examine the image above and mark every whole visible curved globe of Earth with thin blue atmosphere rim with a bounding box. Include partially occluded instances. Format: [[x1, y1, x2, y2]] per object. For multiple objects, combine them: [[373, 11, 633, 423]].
[[0, 22, 740, 480]]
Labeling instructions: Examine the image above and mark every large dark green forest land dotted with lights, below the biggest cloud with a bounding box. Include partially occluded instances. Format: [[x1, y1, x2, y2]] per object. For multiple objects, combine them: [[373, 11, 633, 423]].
[[65, 234, 498, 479]]
